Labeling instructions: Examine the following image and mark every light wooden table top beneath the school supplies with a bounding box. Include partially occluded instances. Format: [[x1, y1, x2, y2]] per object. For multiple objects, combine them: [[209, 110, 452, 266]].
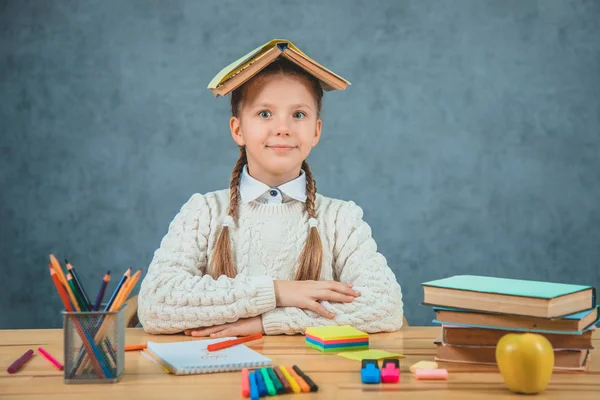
[[0, 327, 600, 400]]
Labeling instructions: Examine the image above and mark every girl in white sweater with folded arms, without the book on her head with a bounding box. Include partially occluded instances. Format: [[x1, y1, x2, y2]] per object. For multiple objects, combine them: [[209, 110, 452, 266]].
[[138, 47, 403, 337]]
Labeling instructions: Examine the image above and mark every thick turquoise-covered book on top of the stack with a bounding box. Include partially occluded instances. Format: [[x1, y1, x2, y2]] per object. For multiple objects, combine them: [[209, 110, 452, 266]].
[[422, 275, 596, 318]]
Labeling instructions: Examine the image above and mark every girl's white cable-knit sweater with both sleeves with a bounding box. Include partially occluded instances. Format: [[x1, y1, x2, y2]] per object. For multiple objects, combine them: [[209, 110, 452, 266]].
[[138, 190, 403, 335]]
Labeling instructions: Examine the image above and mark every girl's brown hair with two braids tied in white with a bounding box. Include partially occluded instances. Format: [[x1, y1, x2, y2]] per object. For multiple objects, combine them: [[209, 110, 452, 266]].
[[210, 58, 323, 280]]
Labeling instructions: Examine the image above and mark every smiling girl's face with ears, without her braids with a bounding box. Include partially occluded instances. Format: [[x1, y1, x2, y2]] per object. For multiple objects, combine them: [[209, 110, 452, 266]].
[[229, 75, 322, 186]]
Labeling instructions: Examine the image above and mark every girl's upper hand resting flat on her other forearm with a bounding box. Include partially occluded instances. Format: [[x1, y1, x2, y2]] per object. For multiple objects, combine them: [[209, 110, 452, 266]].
[[273, 281, 360, 318]]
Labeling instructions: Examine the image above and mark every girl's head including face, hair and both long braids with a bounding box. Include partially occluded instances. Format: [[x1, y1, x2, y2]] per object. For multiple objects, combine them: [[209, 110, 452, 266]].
[[210, 58, 323, 280]]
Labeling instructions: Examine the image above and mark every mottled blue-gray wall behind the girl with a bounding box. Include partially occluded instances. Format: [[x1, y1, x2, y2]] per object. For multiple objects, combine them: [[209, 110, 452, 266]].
[[0, 0, 600, 328]]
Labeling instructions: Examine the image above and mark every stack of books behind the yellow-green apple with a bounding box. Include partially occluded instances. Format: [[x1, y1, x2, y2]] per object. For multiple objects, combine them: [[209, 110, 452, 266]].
[[422, 275, 599, 370]]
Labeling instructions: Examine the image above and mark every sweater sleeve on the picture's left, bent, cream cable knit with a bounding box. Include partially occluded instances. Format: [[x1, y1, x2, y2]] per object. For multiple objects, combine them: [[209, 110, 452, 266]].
[[138, 194, 275, 334]]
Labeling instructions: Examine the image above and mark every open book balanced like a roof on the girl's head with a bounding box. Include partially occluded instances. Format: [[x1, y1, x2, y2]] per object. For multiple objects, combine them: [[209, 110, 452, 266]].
[[208, 39, 350, 97]]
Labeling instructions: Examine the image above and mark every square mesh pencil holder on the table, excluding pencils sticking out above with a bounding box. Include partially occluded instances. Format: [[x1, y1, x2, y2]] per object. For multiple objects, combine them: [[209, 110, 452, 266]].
[[63, 308, 125, 383]]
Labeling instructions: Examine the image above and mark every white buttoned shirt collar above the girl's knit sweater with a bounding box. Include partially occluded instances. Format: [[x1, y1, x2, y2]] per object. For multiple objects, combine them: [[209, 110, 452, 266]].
[[240, 165, 306, 204]]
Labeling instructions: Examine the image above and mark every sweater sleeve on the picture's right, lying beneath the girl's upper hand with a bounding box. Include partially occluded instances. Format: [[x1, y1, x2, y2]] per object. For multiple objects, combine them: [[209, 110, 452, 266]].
[[263, 202, 403, 335]]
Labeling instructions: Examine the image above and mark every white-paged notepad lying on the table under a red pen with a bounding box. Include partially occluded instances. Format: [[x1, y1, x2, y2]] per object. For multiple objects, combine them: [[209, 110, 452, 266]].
[[146, 338, 272, 375]]
